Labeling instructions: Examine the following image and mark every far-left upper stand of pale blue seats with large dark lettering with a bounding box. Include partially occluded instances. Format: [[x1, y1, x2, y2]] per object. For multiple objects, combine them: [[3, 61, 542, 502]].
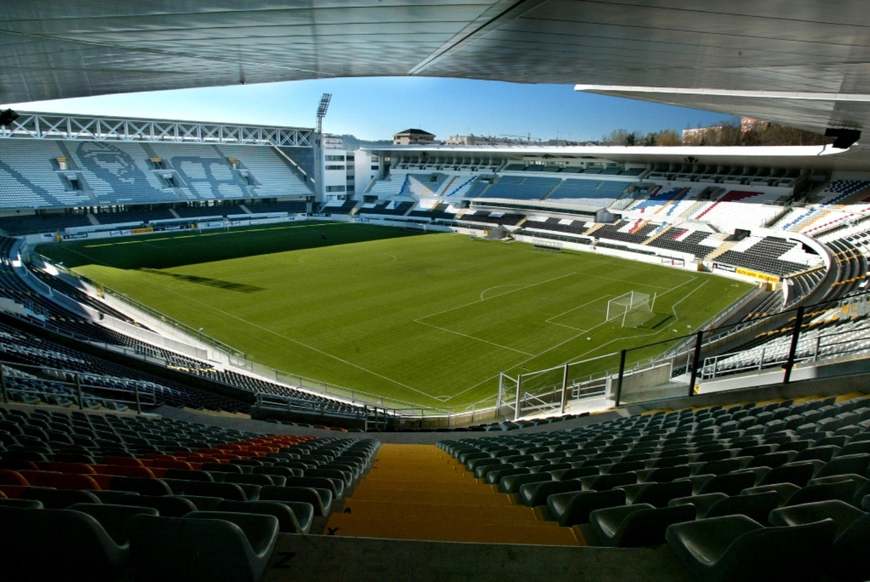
[[0, 140, 311, 209]]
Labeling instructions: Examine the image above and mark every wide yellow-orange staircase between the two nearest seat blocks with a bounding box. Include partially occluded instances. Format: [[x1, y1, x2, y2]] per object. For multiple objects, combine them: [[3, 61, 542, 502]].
[[326, 444, 585, 546]]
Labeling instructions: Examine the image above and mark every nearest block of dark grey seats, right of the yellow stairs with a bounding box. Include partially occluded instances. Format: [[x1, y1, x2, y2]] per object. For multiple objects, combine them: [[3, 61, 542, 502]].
[[439, 396, 870, 580]]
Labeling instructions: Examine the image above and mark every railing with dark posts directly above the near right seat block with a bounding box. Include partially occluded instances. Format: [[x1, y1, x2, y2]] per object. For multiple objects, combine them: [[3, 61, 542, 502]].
[[497, 292, 870, 419]]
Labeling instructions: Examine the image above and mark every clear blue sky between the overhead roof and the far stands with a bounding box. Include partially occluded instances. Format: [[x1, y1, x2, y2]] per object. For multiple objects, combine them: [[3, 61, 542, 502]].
[[3, 77, 731, 139]]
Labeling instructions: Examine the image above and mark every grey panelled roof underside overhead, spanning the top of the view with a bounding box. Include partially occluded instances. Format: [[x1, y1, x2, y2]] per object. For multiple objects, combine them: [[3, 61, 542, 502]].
[[0, 0, 870, 136]]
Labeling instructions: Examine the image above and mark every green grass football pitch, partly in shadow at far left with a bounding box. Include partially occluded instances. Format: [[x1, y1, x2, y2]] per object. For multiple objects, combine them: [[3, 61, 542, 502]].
[[38, 222, 749, 410]]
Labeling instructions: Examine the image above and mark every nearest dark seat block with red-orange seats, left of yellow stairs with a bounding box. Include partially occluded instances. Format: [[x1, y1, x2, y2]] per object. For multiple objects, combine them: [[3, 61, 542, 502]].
[[0, 406, 377, 581]]
